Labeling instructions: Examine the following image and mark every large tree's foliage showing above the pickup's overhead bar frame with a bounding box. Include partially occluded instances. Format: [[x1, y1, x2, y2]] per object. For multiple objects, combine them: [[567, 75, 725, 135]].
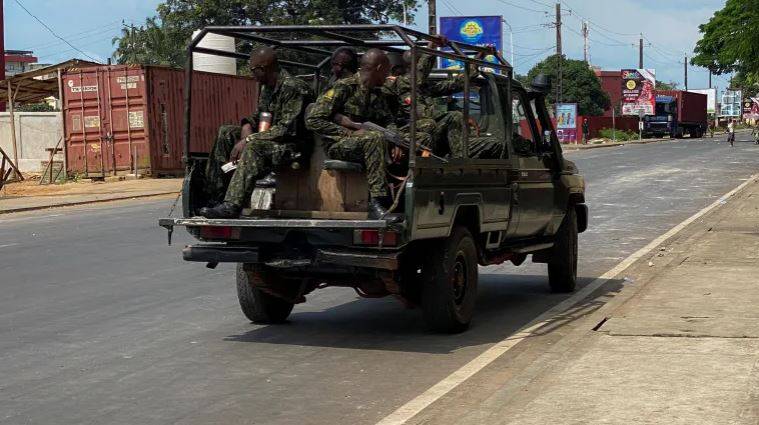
[[113, 0, 417, 66]]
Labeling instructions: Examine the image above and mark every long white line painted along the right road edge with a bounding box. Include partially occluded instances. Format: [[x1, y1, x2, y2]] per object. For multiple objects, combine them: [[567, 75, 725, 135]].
[[377, 174, 759, 425]]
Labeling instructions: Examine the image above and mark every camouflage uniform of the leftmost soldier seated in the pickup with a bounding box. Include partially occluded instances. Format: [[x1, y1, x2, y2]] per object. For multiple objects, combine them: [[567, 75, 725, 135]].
[[224, 70, 314, 207]]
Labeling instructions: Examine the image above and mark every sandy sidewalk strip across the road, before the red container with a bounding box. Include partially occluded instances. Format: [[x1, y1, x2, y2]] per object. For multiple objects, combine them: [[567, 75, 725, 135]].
[[0, 179, 182, 214]]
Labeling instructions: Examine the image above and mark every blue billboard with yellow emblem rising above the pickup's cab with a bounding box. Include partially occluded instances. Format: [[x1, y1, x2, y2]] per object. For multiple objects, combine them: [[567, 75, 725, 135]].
[[440, 16, 503, 69]]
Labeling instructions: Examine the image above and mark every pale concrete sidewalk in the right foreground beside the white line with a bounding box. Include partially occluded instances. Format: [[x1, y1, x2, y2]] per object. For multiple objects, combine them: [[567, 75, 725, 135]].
[[407, 174, 759, 425]]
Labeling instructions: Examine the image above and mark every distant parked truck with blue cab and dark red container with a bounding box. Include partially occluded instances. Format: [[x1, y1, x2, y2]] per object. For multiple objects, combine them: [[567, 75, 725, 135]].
[[643, 90, 708, 139]]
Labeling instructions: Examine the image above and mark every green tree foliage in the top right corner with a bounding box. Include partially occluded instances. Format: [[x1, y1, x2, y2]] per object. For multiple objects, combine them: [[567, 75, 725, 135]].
[[691, 0, 759, 82]]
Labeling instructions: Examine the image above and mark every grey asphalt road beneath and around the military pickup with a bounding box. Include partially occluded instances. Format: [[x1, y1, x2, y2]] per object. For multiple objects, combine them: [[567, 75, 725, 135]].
[[0, 136, 759, 424]]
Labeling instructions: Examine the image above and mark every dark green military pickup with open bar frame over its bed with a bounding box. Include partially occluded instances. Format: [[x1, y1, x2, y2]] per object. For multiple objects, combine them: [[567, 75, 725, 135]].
[[159, 25, 588, 333]]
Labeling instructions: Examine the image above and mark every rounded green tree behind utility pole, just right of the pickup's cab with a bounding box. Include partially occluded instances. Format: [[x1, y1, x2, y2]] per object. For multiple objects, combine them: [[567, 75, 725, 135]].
[[527, 55, 611, 115]]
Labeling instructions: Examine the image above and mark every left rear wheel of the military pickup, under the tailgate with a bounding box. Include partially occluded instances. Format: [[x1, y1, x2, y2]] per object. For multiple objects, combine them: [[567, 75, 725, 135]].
[[237, 264, 293, 324]]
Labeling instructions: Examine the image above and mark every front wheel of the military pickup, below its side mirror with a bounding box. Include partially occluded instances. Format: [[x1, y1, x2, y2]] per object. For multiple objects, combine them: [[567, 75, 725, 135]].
[[548, 206, 577, 292]]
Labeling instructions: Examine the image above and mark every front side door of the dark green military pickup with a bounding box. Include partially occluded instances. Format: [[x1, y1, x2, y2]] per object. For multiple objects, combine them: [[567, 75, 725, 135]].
[[512, 89, 554, 237]]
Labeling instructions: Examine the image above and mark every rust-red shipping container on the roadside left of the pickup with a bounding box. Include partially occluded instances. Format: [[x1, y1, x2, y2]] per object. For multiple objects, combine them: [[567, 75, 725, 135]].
[[62, 65, 258, 177]]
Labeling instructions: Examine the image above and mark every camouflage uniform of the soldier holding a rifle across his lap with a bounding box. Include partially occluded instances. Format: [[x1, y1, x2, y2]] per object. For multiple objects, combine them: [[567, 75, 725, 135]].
[[306, 74, 396, 197]]
